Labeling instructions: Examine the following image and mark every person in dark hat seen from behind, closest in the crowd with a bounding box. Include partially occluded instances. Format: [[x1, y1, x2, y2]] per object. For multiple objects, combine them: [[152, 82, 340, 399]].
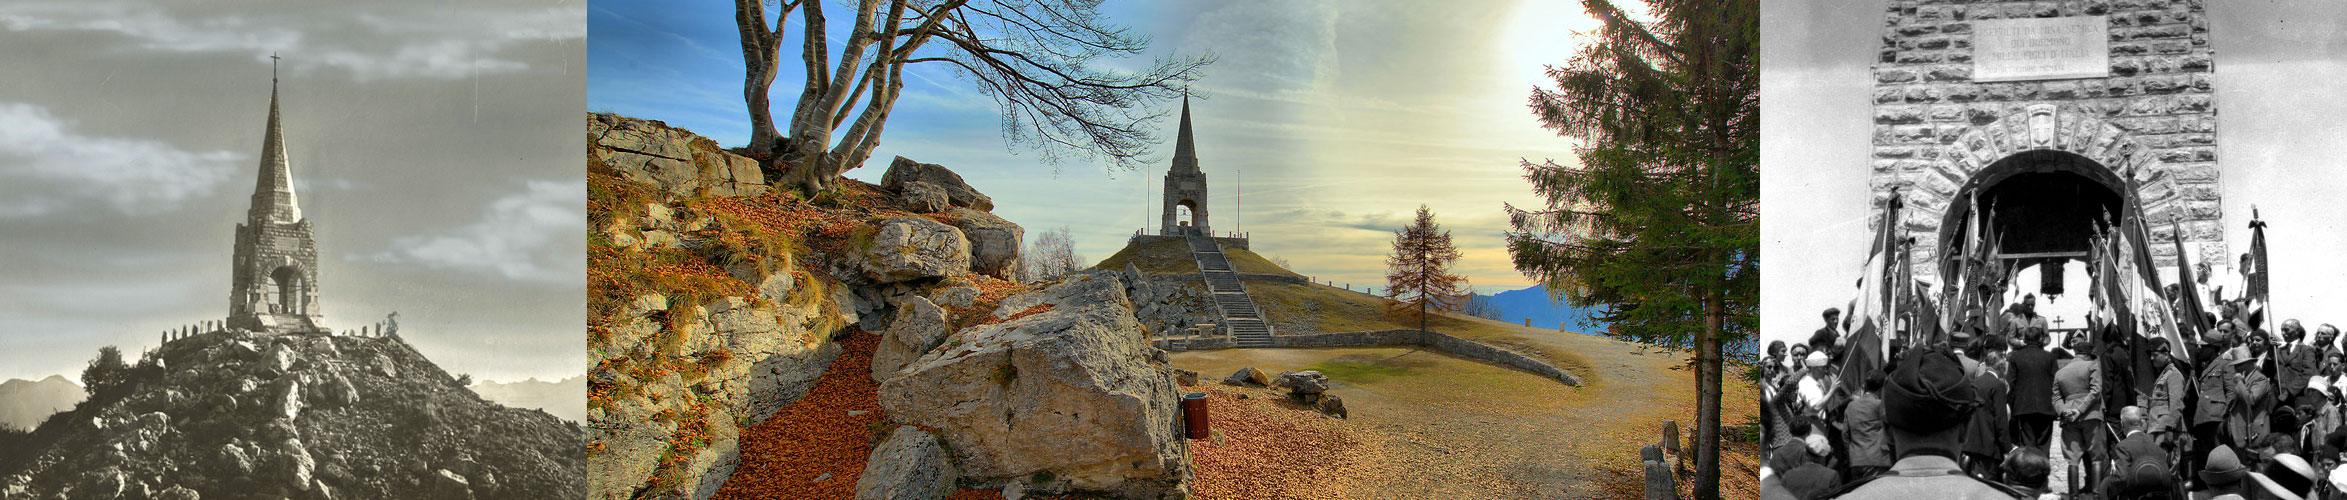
[[1828, 350, 2018, 500]]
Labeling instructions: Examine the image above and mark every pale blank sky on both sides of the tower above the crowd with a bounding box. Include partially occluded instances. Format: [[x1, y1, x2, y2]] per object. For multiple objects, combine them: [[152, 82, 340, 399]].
[[1760, 0, 2347, 352]]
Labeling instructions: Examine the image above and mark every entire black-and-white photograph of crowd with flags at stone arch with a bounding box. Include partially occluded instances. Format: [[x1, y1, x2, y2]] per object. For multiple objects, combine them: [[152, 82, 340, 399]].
[[1758, 0, 2347, 500]]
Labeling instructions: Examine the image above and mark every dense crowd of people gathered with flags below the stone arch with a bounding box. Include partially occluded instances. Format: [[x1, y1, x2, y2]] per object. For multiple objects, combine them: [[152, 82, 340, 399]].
[[1760, 296, 2347, 500]]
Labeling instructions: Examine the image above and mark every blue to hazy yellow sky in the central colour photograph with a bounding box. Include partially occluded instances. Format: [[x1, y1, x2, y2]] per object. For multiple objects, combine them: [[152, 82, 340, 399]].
[[587, 0, 1594, 293]]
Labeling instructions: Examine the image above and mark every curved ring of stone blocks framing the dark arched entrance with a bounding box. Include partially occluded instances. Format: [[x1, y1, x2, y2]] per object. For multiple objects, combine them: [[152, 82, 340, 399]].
[[1875, 103, 2223, 282]]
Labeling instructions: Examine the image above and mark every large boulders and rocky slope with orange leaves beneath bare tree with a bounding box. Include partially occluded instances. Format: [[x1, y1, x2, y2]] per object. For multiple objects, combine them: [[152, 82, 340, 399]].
[[587, 115, 1190, 500]]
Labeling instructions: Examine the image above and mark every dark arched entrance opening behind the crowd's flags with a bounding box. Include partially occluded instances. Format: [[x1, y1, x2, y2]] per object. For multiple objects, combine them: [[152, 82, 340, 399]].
[[1936, 150, 2129, 317]]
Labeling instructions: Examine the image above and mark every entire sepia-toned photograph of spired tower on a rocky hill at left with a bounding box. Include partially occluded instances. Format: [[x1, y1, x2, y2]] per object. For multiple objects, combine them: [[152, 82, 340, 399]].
[[0, 0, 587, 500]]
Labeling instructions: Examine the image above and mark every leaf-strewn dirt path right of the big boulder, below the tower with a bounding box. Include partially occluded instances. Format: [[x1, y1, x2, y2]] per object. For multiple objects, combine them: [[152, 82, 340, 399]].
[[1174, 340, 1751, 498]]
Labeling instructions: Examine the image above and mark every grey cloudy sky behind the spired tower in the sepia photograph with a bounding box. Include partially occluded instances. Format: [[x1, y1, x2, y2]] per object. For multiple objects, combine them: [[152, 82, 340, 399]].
[[0, 0, 587, 380]]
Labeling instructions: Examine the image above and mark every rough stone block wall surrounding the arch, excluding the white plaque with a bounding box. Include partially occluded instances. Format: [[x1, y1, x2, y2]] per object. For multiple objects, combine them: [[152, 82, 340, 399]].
[[1871, 0, 2225, 277]]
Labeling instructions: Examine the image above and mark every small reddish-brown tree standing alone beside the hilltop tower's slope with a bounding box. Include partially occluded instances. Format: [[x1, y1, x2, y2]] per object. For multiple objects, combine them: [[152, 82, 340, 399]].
[[1385, 204, 1467, 331]]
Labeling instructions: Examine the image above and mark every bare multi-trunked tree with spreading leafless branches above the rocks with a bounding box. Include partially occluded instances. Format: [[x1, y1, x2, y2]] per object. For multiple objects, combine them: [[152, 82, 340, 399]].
[[735, 0, 1213, 195]]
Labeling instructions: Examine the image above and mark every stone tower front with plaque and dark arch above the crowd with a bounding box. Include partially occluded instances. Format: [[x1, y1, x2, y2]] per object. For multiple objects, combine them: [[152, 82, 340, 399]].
[[1871, 0, 2225, 282]]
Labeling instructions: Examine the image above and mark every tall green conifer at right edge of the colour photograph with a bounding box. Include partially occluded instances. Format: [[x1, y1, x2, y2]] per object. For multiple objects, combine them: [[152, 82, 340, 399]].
[[1507, 0, 1760, 500]]
